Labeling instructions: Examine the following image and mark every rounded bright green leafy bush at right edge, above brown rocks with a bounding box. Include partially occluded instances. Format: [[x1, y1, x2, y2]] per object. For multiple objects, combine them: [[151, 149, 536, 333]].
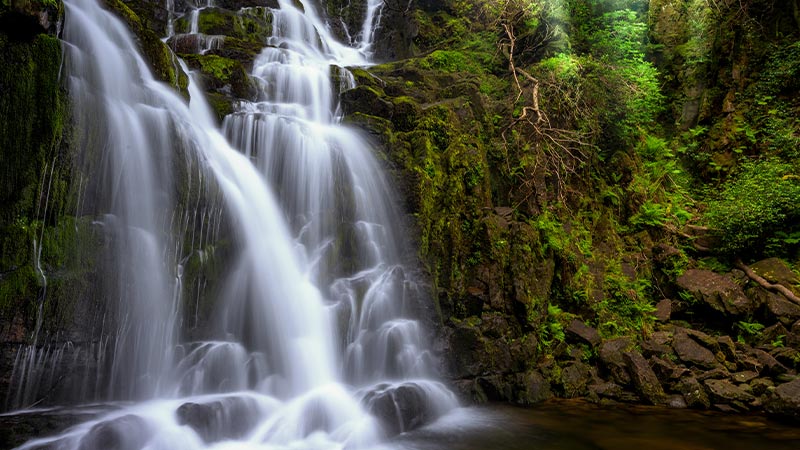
[[705, 158, 800, 254]]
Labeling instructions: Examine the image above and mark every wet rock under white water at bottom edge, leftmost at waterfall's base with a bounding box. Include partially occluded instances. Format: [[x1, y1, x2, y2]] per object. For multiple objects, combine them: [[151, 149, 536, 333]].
[[78, 414, 151, 450]]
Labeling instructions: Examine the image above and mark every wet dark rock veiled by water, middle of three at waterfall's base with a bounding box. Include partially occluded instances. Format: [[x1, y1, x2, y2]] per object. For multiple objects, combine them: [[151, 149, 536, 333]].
[[175, 397, 258, 443]]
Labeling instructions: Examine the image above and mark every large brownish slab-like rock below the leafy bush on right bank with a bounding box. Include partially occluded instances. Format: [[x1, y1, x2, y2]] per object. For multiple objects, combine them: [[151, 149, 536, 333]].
[[676, 269, 754, 316]]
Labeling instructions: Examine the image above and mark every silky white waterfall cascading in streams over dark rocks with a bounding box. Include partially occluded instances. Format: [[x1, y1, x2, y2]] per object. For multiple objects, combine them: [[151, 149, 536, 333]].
[[12, 0, 456, 449]]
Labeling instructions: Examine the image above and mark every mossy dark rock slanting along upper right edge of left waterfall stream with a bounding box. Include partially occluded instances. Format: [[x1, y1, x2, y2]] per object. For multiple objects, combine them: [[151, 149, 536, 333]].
[[104, 0, 189, 96]]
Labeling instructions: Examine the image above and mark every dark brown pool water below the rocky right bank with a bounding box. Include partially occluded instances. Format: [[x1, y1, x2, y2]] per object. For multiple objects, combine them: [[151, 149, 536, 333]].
[[398, 400, 800, 450]]
